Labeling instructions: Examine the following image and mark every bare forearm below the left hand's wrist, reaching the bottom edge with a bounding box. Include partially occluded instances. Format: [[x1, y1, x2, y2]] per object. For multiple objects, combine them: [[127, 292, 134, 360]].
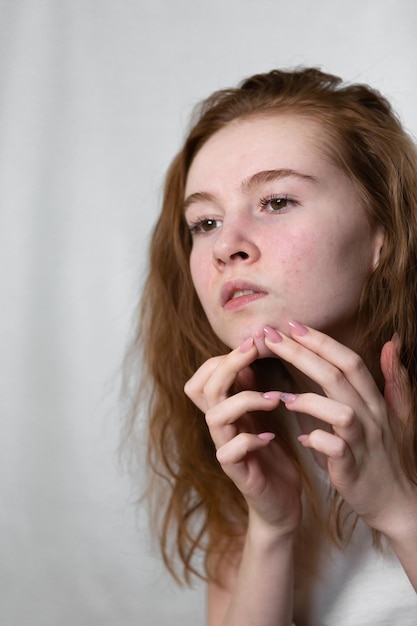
[[209, 525, 294, 626]]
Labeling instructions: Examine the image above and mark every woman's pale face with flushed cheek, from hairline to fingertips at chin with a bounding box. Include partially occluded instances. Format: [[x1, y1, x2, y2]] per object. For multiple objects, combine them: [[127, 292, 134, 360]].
[[185, 114, 383, 348]]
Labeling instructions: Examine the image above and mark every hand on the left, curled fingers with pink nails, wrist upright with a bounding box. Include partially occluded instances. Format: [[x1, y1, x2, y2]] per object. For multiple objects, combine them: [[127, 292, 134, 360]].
[[185, 338, 301, 535]]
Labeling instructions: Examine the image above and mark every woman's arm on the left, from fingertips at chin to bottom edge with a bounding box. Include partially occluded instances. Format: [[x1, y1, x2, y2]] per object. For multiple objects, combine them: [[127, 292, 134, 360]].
[[185, 341, 301, 626]]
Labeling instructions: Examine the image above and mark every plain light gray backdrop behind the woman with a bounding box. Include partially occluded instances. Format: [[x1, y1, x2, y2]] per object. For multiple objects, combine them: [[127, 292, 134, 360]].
[[0, 0, 417, 626]]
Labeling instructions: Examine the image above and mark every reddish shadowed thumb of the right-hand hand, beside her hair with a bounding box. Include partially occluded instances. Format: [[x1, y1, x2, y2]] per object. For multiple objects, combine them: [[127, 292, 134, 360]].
[[380, 333, 411, 421]]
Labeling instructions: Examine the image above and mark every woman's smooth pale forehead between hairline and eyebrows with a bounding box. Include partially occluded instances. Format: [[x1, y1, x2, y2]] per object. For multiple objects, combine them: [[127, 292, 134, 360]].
[[186, 114, 330, 195]]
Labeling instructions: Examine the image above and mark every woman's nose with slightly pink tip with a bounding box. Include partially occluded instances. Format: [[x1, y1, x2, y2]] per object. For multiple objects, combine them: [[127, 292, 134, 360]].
[[213, 222, 260, 269]]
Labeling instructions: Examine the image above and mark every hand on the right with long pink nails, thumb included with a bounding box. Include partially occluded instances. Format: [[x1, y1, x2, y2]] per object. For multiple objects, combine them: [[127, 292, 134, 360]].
[[265, 322, 417, 536]]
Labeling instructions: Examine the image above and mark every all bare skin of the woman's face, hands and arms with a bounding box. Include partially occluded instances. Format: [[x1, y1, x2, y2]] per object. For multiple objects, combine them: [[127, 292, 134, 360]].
[[185, 115, 417, 626]]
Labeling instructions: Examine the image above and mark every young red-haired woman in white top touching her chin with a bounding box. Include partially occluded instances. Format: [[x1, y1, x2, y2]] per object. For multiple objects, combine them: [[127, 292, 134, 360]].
[[126, 69, 417, 626]]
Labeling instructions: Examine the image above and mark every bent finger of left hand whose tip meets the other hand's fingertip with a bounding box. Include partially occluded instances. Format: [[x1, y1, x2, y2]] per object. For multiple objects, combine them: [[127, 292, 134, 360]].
[[206, 391, 280, 449]]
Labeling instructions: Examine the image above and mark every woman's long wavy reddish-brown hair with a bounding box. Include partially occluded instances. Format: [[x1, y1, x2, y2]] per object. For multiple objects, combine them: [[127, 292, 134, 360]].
[[122, 68, 417, 582]]
